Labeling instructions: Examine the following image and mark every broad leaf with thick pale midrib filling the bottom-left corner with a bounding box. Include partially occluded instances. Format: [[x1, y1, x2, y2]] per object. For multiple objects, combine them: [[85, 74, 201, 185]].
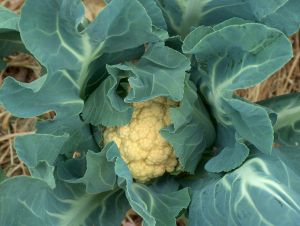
[[0, 176, 129, 226]]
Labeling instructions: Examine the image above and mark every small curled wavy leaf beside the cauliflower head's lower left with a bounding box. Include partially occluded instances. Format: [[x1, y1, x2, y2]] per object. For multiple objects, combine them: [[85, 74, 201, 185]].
[[58, 143, 117, 194]]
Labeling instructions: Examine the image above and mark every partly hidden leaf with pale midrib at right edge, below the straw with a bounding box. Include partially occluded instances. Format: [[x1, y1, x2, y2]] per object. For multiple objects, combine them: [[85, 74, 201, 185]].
[[260, 93, 300, 147]]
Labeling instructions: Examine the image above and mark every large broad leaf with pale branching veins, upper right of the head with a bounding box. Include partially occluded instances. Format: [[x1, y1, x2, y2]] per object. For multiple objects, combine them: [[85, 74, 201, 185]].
[[183, 20, 292, 157]]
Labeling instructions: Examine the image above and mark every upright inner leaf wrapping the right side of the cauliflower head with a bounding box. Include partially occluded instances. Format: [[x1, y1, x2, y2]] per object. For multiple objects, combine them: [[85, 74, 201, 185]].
[[160, 77, 215, 173]]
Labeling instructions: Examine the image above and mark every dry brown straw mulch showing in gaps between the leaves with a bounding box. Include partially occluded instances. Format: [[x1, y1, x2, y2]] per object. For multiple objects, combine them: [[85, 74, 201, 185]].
[[0, 0, 300, 226]]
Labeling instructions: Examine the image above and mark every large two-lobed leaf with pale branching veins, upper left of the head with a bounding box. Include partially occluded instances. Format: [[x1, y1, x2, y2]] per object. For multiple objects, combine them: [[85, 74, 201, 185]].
[[20, 0, 158, 87]]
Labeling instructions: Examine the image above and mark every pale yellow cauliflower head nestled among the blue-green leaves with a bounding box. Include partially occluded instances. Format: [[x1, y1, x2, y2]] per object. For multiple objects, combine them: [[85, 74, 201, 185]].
[[103, 97, 178, 182]]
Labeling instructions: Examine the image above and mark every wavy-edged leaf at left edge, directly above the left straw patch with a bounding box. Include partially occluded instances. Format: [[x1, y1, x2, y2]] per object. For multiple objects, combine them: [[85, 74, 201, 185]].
[[0, 71, 83, 118]]
